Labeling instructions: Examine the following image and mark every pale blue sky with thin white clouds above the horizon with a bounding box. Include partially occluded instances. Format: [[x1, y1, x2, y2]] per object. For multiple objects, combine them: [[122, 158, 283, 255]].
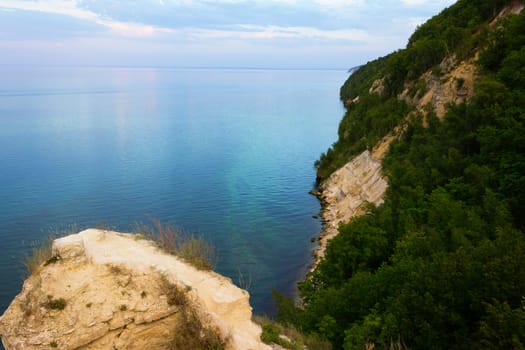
[[0, 0, 455, 69]]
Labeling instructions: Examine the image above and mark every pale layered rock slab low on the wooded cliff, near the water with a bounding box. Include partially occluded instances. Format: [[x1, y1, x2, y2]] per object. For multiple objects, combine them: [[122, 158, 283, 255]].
[[313, 149, 386, 268]]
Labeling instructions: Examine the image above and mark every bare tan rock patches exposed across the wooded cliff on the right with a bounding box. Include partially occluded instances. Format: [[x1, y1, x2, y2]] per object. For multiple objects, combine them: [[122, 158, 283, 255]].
[[314, 13, 490, 268]]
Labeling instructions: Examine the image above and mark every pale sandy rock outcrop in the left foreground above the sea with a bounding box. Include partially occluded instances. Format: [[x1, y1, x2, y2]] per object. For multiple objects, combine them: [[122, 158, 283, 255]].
[[0, 229, 270, 350]]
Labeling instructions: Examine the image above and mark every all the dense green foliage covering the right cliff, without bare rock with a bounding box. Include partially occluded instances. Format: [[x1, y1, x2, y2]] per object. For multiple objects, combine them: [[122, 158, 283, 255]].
[[286, 0, 525, 349]]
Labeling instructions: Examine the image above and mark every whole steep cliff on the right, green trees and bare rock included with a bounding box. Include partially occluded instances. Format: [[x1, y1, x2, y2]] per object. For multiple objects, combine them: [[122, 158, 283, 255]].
[[300, 0, 525, 349]]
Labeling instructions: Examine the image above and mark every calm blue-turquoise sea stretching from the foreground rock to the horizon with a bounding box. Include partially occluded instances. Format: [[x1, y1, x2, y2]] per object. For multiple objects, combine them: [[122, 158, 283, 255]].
[[0, 67, 347, 314]]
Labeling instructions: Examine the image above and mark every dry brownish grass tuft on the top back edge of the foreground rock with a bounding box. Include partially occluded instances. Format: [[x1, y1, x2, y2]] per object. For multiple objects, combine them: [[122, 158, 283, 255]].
[[134, 219, 215, 270]]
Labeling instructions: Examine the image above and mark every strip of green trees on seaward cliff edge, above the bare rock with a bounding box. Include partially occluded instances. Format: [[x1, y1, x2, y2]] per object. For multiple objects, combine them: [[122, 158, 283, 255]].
[[315, 0, 510, 179]]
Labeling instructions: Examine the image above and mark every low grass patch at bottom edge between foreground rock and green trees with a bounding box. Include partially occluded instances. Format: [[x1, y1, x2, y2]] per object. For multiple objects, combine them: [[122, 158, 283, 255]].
[[254, 316, 332, 350]]
